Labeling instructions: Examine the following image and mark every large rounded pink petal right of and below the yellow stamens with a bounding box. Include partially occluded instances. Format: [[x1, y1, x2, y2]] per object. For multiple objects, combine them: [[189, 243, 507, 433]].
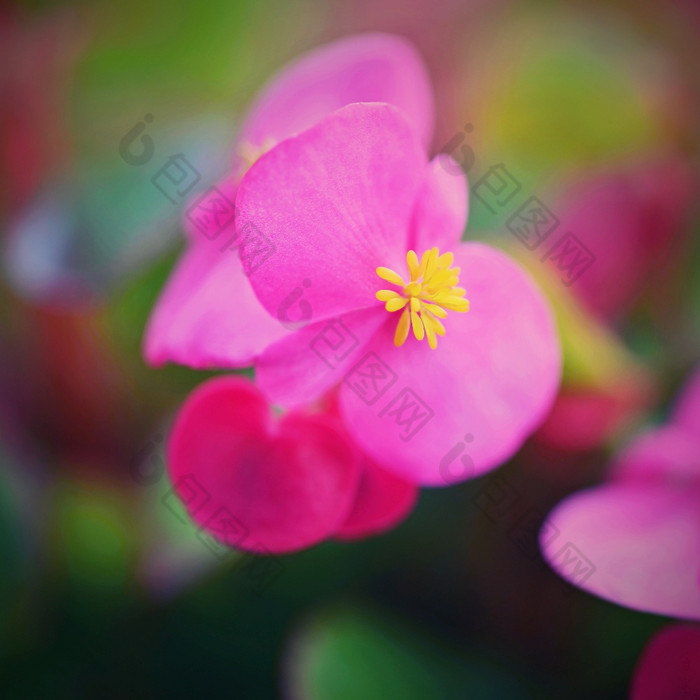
[[340, 243, 561, 486]]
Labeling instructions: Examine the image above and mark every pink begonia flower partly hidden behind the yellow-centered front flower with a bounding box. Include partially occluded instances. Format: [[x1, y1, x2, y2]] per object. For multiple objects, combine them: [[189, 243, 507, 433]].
[[144, 34, 433, 368]]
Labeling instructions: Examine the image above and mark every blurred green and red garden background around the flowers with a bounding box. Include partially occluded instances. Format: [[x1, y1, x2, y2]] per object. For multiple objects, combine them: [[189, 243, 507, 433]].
[[0, 0, 700, 700]]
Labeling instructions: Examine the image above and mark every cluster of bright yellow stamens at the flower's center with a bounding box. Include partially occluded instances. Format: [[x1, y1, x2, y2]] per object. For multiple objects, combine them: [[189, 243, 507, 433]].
[[376, 248, 469, 350]]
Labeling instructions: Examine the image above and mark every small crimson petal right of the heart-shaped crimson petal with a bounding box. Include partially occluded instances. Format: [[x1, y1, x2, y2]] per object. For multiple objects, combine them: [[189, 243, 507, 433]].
[[335, 459, 418, 540]]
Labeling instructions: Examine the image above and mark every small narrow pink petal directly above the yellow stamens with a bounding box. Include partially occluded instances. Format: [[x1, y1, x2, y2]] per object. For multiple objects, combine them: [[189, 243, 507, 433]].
[[409, 154, 469, 257]]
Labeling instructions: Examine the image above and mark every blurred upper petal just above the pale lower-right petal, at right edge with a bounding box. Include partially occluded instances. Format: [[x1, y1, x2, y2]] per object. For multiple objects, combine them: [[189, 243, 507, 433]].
[[613, 425, 700, 486]]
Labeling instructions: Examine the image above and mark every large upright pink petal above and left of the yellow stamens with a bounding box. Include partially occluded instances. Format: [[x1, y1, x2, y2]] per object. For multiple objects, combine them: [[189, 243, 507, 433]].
[[236, 104, 426, 320]]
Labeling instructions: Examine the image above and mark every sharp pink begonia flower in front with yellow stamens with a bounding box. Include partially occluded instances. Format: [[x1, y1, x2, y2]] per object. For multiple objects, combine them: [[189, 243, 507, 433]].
[[236, 104, 561, 485]]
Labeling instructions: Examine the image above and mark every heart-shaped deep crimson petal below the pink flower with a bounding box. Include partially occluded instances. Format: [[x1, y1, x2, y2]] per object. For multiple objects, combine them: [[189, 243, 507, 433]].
[[168, 377, 359, 553]]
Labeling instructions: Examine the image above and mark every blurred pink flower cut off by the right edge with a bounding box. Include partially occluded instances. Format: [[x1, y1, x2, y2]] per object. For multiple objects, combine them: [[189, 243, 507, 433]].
[[540, 369, 700, 619]]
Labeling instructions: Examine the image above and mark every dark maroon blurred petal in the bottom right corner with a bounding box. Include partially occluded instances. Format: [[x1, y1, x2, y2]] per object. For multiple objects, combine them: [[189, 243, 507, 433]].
[[630, 624, 700, 700]]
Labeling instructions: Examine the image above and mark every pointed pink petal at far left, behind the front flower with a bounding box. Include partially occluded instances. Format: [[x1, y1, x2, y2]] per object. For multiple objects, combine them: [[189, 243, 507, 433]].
[[144, 240, 288, 369]]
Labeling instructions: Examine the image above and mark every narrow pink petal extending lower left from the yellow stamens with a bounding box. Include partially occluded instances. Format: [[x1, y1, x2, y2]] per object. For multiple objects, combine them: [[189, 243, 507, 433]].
[[255, 302, 387, 408]]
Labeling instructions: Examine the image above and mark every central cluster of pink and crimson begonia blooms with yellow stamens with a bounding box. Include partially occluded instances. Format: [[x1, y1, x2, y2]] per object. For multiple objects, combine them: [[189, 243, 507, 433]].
[[144, 35, 561, 553]]
